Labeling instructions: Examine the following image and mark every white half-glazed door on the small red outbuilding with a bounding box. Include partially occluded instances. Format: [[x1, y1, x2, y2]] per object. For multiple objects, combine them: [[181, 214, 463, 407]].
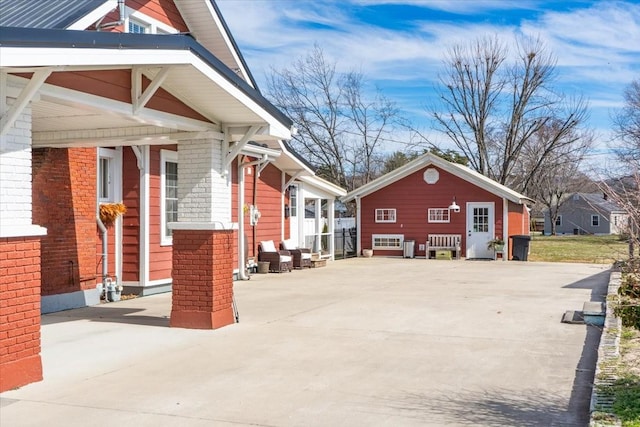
[[467, 202, 495, 259]]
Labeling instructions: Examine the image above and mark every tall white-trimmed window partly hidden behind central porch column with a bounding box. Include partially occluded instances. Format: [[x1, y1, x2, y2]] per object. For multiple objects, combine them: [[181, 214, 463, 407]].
[[160, 150, 178, 245]]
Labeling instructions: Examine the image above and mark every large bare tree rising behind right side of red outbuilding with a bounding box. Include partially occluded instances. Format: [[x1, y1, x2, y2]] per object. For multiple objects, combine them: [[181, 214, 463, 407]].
[[433, 37, 587, 192]]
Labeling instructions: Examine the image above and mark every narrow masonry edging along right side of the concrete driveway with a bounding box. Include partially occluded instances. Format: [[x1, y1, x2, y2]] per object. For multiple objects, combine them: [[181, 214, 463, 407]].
[[589, 271, 622, 427]]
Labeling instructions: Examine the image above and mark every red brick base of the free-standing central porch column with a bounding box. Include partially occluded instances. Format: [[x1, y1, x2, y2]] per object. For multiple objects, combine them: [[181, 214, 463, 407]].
[[170, 230, 234, 329]]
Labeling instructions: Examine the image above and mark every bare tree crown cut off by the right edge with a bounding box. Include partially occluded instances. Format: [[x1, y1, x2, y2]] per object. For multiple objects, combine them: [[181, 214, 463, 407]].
[[613, 79, 640, 168]]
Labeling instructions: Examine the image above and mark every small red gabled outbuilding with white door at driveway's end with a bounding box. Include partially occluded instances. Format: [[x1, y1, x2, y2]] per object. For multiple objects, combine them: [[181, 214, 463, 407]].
[[342, 153, 532, 258]]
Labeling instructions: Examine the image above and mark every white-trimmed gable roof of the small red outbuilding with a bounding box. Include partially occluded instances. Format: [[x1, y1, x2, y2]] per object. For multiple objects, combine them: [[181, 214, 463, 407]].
[[341, 153, 533, 204]]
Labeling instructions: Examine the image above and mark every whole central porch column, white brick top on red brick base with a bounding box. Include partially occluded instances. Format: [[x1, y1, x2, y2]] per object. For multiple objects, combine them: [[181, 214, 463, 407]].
[[169, 139, 237, 329]]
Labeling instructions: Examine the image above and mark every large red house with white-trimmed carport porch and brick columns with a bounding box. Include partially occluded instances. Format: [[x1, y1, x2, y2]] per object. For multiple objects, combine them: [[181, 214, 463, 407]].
[[0, 0, 344, 391]]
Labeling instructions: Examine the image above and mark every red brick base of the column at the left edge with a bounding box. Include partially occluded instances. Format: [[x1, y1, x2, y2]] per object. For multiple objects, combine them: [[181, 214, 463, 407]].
[[0, 237, 42, 392]]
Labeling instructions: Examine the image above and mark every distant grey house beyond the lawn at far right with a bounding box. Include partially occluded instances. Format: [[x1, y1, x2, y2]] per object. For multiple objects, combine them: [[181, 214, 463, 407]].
[[544, 193, 627, 235]]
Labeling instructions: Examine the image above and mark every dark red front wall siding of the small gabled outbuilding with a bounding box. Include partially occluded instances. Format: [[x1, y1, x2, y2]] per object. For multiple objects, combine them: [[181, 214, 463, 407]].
[[361, 166, 503, 256]]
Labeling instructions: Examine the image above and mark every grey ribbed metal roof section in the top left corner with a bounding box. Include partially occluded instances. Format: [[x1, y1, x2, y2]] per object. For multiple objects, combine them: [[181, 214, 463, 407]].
[[0, 0, 105, 30]]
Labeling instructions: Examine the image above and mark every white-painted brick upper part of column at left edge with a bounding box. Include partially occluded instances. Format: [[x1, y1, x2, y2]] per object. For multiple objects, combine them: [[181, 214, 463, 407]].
[[0, 90, 47, 237]]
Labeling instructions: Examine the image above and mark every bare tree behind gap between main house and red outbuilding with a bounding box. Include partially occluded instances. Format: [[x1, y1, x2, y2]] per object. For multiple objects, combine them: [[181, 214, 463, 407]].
[[267, 45, 399, 190]]
